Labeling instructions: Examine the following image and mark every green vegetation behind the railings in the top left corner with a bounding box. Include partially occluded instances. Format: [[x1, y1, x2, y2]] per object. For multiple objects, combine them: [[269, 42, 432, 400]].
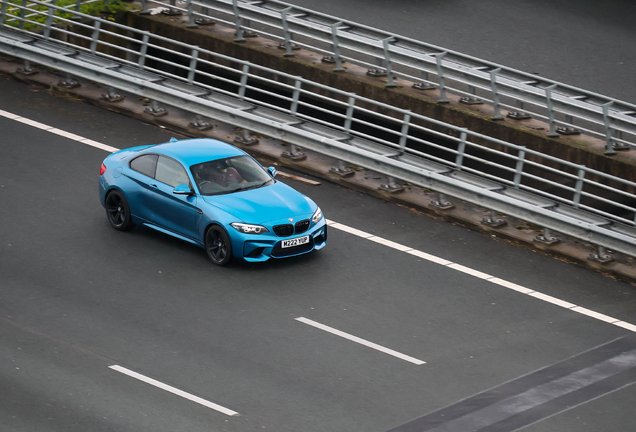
[[4, 0, 131, 30]]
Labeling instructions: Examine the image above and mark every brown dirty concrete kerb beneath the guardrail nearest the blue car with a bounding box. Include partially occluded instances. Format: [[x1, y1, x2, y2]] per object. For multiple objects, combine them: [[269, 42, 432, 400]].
[[0, 58, 636, 286]]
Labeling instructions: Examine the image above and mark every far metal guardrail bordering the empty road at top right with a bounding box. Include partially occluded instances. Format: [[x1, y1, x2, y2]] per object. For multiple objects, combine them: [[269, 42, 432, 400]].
[[141, 0, 636, 155]]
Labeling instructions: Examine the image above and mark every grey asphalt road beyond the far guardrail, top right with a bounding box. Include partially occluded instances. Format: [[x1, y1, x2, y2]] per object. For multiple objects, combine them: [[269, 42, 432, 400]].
[[286, 0, 636, 103]]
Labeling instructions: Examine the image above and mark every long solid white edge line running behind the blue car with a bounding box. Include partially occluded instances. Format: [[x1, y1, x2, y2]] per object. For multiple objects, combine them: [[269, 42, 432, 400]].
[[0, 110, 636, 333]]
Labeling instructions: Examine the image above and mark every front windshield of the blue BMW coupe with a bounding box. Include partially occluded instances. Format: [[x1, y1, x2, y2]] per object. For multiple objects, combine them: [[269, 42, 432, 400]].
[[190, 156, 274, 195]]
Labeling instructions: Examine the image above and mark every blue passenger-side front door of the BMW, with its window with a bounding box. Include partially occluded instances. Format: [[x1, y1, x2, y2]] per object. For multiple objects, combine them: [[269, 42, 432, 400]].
[[144, 155, 198, 239]]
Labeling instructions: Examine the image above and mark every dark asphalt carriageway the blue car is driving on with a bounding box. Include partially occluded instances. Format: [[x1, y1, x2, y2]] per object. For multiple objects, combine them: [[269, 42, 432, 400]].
[[0, 67, 636, 432]]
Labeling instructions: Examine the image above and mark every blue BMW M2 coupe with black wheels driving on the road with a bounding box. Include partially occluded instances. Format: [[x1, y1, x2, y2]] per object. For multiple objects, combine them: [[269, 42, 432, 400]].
[[99, 139, 327, 265]]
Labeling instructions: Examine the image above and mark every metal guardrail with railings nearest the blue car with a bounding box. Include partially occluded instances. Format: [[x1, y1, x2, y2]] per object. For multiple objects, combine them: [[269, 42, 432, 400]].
[[0, 0, 636, 256]]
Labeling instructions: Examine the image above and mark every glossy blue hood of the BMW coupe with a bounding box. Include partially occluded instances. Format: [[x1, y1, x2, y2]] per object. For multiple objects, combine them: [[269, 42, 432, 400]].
[[203, 182, 317, 224]]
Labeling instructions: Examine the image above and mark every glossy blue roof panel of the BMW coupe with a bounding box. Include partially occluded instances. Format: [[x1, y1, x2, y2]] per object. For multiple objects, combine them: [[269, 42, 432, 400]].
[[148, 138, 246, 167]]
